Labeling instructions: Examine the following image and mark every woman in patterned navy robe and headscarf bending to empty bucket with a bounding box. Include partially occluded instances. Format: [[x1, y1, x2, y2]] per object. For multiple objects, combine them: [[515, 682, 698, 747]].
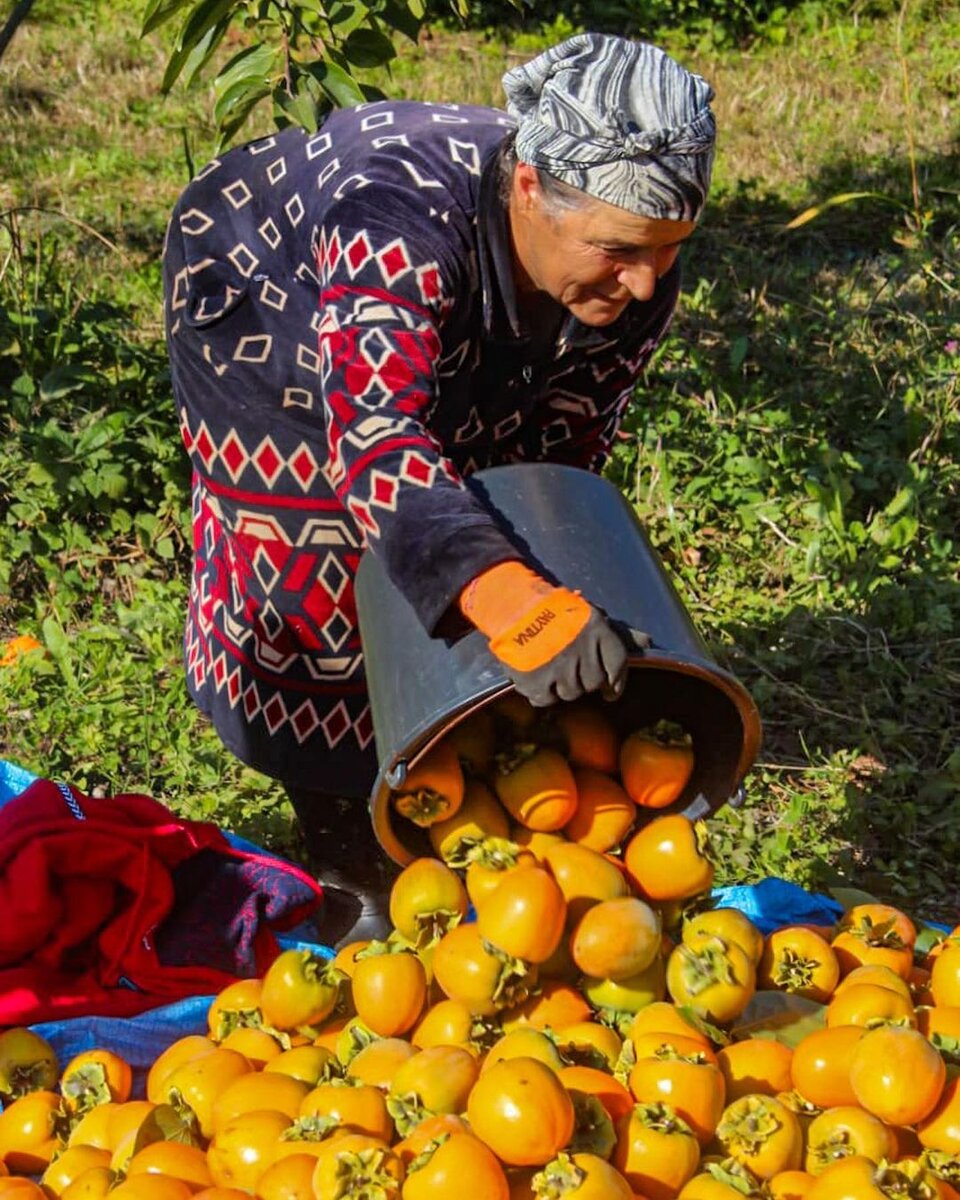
[[164, 34, 714, 936]]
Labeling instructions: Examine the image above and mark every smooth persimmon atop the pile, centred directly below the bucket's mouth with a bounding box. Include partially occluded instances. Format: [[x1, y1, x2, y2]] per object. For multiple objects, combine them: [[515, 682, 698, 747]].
[[476, 865, 566, 962]]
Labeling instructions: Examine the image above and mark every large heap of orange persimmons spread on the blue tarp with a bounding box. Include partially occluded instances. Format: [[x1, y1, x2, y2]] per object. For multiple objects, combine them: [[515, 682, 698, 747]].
[[0, 844, 960, 1200]]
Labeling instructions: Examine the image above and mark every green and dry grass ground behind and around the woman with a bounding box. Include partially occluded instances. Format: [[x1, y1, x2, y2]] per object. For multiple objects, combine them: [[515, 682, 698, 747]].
[[0, 0, 960, 922]]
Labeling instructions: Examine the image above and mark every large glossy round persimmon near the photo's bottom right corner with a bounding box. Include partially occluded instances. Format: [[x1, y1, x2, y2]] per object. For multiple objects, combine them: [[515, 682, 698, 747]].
[[850, 1025, 947, 1126]]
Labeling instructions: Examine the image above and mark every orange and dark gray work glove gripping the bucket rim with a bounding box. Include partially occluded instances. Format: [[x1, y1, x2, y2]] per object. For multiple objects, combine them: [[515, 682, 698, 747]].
[[460, 559, 626, 708]]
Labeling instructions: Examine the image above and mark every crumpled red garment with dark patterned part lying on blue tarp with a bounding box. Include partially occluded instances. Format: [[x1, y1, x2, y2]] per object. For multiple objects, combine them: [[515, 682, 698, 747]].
[[0, 780, 323, 1026]]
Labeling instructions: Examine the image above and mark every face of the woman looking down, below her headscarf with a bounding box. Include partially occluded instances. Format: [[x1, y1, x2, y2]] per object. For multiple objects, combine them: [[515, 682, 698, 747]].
[[510, 163, 696, 325]]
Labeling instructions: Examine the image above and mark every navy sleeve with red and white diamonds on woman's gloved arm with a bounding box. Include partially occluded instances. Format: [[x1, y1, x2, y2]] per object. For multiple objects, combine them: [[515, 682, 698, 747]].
[[317, 185, 516, 632]]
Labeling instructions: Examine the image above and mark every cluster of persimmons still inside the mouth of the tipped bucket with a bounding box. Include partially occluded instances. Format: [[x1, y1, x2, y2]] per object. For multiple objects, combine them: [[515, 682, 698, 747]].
[[391, 694, 694, 844]]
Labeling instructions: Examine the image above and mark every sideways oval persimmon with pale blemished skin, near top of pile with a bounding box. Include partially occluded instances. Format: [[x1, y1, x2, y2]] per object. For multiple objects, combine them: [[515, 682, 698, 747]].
[[570, 896, 660, 982]]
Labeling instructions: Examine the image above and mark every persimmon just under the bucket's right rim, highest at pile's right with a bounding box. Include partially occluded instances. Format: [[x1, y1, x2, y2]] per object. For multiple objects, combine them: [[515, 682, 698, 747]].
[[623, 812, 714, 901]]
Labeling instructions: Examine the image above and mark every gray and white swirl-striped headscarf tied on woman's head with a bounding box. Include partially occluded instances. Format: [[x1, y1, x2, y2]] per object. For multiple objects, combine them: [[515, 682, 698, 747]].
[[503, 34, 716, 221]]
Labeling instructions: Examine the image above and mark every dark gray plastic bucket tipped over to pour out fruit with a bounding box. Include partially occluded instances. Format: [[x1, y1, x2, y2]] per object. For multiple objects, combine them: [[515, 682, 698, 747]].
[[356, 463, 761, 864]]
